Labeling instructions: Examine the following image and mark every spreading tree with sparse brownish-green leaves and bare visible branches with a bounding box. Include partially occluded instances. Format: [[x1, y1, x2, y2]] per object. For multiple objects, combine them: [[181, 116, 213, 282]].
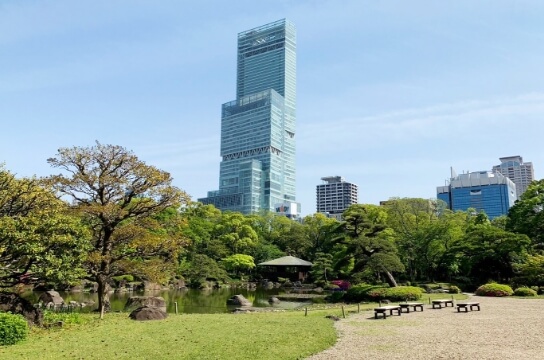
[[48, 142, 189, 318]]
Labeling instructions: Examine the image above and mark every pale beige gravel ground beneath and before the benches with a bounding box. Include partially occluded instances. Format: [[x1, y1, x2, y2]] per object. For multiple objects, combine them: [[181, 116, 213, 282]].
[[309, 296, 544, 360]]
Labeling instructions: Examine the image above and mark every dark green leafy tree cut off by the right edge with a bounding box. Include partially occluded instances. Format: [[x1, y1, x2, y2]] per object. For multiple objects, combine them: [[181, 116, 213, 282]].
[[506, 179, 544, 250]]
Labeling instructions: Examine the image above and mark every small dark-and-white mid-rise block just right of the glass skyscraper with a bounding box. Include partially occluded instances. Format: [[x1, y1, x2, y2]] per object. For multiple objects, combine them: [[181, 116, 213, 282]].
[[316, 176, 358, 220]]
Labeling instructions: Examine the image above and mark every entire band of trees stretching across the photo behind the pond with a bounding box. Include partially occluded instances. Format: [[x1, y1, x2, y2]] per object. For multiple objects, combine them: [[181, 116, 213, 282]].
[[0, 142, 544, 317]]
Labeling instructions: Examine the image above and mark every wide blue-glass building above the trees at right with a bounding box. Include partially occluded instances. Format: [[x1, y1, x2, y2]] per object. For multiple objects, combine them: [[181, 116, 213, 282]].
[[436, 170, 516, 219]]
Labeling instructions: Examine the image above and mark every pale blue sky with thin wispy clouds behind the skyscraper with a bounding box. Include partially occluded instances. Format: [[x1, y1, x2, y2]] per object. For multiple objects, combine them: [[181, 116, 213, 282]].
[[0, 0, 544, 215]]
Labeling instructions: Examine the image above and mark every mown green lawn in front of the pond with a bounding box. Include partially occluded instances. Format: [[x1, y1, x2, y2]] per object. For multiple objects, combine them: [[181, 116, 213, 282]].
[[0, 310, 336, 360]]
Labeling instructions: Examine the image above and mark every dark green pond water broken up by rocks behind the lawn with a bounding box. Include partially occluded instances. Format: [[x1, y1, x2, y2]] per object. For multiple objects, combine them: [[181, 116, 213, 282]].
[[23, 288, 305, 314]]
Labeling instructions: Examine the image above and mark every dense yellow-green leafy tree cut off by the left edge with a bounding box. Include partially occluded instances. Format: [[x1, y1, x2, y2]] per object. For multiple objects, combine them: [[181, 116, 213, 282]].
[[0, 168, 89, 287]]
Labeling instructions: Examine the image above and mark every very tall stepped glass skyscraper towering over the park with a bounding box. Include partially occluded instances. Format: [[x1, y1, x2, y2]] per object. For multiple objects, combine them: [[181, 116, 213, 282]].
[[199, 19, 300, 217]]
